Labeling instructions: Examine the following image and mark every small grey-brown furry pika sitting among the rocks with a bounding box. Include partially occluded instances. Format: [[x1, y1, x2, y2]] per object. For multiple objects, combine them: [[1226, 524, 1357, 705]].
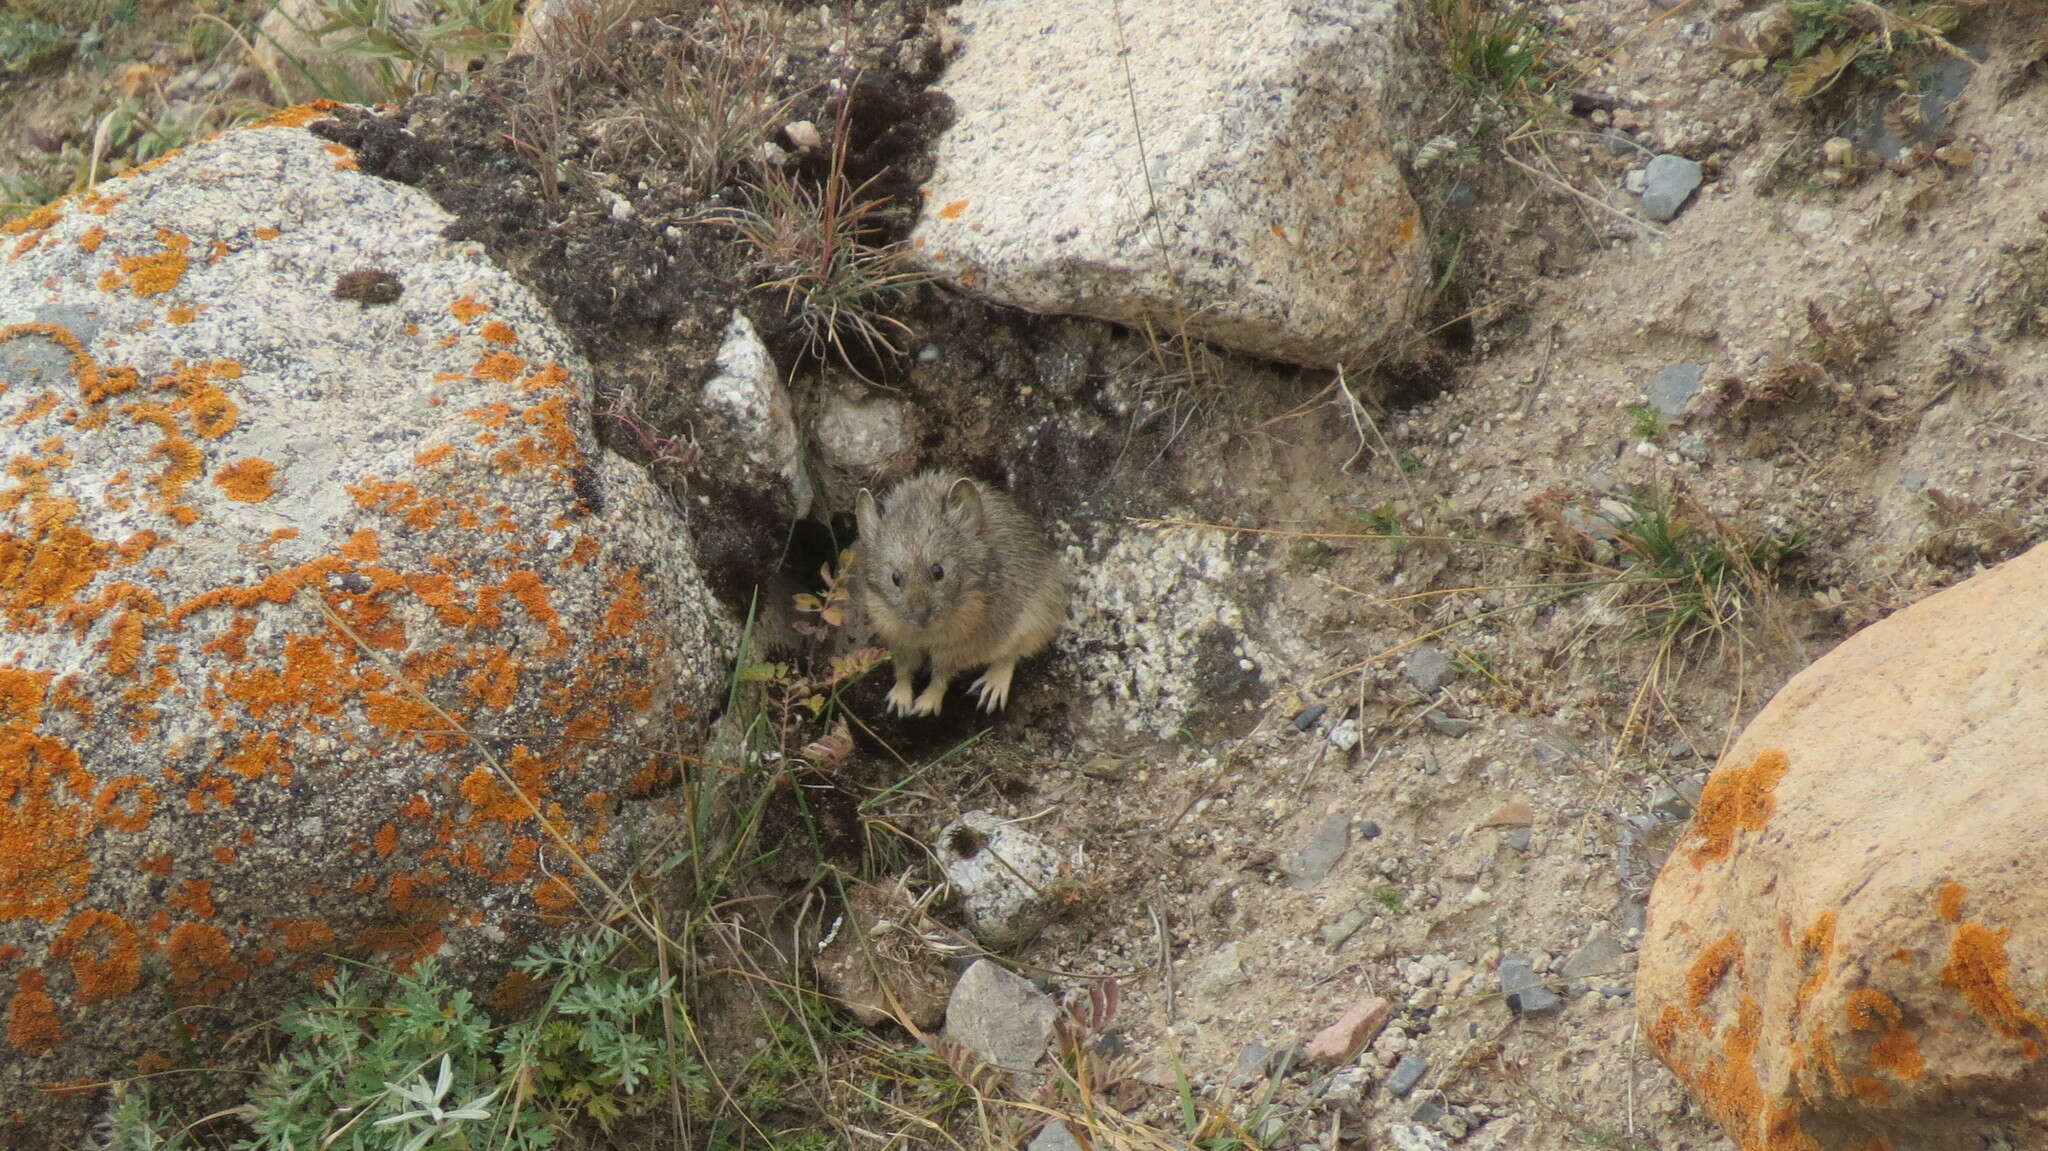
[[854, 471, 1067, 715]]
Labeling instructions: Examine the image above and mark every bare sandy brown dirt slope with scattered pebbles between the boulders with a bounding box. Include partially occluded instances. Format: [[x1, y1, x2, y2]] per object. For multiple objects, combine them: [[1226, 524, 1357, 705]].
[[12, 0, 2048, 1151]]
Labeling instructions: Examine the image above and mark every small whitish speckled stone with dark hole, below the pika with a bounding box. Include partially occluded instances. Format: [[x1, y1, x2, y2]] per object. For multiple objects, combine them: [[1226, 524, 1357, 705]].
[[938, 811, 1087, 950]]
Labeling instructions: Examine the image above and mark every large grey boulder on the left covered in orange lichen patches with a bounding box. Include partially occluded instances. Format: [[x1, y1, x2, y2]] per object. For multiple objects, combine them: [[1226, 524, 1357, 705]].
[[0, 106, 729, 1147]]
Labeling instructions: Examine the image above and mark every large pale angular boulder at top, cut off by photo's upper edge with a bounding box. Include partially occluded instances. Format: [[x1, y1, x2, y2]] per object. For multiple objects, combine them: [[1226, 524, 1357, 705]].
[[911, 0, 1427, 367]]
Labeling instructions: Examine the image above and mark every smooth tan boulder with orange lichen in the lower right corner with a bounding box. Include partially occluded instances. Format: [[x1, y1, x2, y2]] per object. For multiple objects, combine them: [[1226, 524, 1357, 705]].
[[1636, 549, 2048, 1151]]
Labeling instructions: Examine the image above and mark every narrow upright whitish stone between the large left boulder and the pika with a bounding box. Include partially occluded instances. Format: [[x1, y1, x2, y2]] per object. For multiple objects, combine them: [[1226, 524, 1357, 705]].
[[696, 311, 815, 512]]
